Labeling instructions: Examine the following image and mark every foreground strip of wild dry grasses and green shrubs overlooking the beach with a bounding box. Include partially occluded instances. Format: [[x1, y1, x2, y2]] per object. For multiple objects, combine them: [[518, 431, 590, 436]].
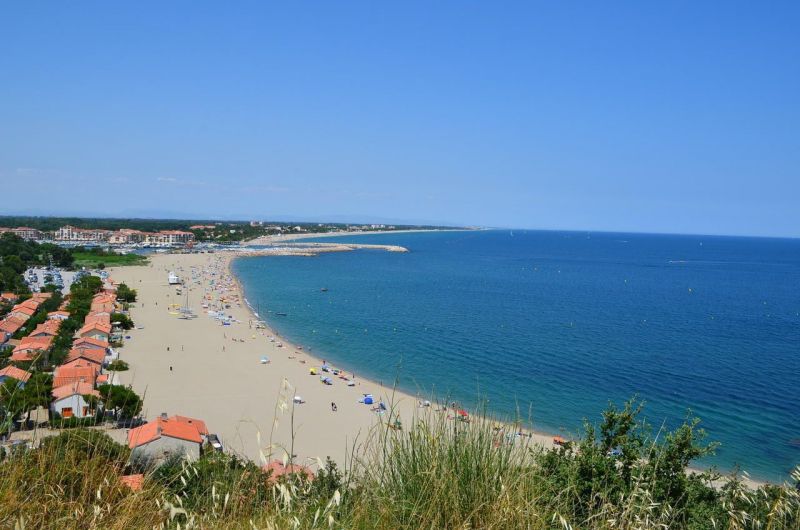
[[0, 403, 800, 530]]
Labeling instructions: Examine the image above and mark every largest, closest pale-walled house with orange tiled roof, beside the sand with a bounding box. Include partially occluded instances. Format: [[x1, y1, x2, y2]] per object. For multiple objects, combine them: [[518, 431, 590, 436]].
[[128, 414, 208, 462]]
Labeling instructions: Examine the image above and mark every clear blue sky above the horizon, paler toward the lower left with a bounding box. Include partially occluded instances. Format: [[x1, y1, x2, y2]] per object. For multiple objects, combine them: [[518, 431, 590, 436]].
[[0, 0, 800, 236]]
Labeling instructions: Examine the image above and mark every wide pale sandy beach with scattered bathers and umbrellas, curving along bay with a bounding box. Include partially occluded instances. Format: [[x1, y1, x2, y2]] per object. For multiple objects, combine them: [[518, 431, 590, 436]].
[[109, 253, 552, 470]]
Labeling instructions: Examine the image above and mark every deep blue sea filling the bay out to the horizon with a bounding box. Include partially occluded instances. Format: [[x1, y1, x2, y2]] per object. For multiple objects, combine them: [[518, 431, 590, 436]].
[[228, 230, 800, 481]]
